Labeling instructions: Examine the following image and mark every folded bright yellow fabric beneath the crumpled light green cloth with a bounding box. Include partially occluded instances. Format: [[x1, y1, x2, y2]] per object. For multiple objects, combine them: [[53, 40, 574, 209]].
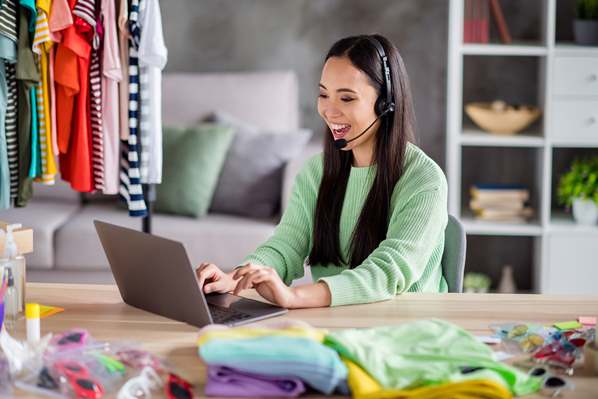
[[343, 359, 512, 399]]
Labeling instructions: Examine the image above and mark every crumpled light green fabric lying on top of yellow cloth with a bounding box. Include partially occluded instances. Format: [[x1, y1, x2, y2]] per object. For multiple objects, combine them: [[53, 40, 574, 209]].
[[324, 320, 540, 395]]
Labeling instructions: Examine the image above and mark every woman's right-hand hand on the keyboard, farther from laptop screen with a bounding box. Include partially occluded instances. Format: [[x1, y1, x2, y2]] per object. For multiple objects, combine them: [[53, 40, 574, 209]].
[[233, 263, 296, 308]]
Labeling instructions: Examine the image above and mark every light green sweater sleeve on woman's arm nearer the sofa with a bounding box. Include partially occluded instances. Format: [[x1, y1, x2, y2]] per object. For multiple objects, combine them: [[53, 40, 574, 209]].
[[243, 158, 319, 285]]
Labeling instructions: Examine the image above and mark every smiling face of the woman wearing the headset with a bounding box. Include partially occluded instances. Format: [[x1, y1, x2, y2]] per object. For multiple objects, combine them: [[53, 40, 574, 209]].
[[318, 57, 380, 151]]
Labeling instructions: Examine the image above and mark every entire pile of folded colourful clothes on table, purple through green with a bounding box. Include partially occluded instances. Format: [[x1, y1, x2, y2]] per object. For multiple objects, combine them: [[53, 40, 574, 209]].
[[198, 320, 541, 399]]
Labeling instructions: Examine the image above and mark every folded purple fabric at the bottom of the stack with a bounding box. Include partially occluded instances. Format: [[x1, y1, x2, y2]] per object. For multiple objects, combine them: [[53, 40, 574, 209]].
[[205, 365, 305, 397]]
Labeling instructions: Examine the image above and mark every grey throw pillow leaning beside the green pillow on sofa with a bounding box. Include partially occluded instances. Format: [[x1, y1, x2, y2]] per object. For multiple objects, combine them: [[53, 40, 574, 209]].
[[206, 112, 311, 218]]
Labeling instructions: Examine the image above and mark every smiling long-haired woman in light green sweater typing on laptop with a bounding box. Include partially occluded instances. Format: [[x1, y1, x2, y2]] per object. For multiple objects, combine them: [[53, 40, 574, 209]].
[[197, 35, 448, 308]]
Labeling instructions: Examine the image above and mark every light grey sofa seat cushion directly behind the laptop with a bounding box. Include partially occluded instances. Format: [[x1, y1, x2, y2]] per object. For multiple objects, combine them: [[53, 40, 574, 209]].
[[56, 204, 275, 270]]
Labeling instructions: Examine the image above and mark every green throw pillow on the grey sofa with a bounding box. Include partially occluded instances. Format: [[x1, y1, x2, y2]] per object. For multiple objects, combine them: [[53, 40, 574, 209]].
[[155, 123, 234, 217]]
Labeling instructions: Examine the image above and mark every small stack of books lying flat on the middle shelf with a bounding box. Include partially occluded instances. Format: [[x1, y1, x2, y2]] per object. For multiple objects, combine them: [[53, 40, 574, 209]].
[[469, 184, 534, 223]]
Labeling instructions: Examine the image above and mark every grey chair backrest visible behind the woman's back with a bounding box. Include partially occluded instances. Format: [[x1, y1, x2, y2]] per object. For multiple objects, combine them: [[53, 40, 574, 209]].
[[442, 215, 467, 292]]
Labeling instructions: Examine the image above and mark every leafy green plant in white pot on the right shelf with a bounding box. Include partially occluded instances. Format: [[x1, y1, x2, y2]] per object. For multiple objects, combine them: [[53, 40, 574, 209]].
[[557, 157, 598, 225]]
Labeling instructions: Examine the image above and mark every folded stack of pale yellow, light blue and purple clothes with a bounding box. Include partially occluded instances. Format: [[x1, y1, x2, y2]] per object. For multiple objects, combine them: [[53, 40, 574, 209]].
[[198, 327, 348, 397]]
